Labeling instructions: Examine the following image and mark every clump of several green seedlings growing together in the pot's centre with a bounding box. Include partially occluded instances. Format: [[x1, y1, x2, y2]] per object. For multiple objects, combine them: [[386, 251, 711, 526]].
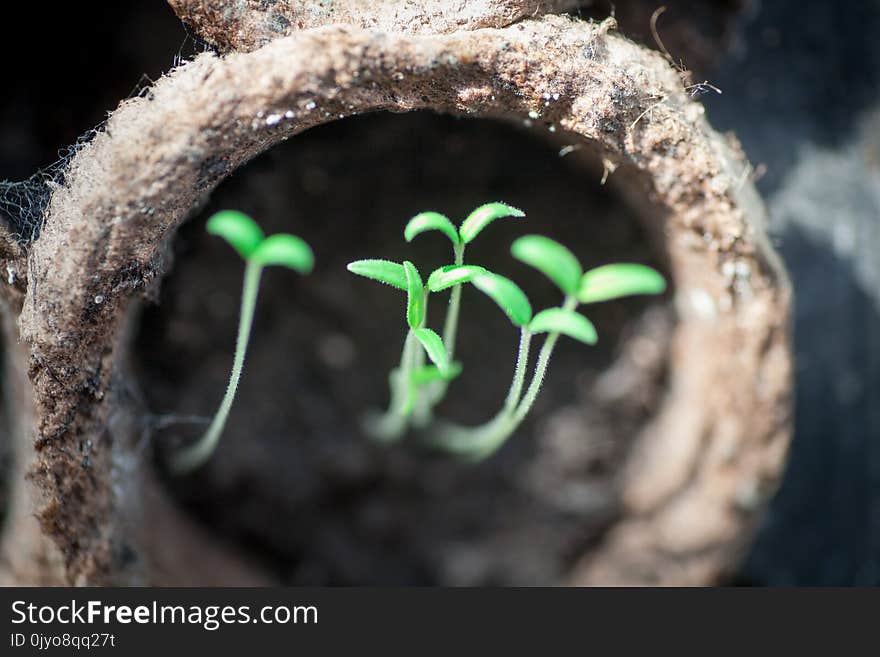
[[348, 203, 666, 460]]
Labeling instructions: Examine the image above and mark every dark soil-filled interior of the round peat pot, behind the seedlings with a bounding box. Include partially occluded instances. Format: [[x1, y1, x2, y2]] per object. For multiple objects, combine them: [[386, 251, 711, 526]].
[[134, 113, 671, 585]]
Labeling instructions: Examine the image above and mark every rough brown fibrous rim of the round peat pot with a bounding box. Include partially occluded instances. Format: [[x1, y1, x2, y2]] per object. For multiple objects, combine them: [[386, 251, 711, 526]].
[[0, 9, 790, 584]]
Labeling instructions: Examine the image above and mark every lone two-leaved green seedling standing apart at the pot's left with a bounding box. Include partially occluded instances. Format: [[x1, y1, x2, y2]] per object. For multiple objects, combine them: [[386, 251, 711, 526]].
[[171, 210, 314, 474]]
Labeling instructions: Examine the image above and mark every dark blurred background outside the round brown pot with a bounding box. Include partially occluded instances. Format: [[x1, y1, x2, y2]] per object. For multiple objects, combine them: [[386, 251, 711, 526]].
[[0, 0, 880, 585]]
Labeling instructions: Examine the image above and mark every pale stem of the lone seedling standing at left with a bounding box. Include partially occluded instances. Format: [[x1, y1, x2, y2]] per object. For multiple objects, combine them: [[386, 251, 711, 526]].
[[171, 262, 263, 474]]
